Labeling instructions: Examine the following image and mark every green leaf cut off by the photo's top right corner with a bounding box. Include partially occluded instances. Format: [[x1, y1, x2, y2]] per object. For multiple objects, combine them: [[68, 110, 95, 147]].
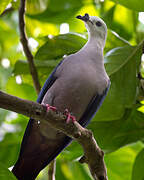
[[112, 0, 144, 12]]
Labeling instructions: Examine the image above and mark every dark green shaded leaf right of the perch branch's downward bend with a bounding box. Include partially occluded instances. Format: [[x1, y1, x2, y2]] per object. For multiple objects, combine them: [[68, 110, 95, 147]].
[[88, 107, 144, 152]]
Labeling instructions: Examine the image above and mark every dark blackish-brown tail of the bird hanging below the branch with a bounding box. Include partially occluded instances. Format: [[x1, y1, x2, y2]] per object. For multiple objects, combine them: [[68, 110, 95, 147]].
[[12, 119, 72, 180]]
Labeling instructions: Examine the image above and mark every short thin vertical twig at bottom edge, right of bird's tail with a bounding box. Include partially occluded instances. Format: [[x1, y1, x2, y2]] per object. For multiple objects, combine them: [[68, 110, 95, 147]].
[[48, 159, 56, 180]]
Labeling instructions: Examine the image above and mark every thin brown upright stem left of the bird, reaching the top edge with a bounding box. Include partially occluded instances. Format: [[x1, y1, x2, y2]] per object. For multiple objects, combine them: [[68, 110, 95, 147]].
[[19, 0, 41, 94]]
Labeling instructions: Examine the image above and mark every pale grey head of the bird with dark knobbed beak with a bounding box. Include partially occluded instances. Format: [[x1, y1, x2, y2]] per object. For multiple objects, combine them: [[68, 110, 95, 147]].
[[77, 13, 107, 45]]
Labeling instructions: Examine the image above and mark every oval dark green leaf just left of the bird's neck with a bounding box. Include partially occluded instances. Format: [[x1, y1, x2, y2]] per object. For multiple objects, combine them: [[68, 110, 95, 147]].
[[35, 33, 86, 60]]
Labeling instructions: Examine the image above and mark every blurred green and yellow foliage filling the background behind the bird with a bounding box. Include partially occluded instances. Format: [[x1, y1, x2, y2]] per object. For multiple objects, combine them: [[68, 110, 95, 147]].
[[0, 0, 144, 180]]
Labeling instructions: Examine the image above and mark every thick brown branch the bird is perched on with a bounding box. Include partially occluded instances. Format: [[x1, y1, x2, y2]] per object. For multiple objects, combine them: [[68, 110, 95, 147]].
[[0, 91, 107, 180]]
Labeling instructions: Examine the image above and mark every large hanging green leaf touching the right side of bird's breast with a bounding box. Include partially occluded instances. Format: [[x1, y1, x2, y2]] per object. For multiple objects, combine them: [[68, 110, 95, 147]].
[[96, 44, 142, 121]]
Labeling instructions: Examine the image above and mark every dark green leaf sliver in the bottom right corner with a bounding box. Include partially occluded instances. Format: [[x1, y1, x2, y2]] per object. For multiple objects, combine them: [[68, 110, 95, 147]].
[[132, 149, 144, 180]]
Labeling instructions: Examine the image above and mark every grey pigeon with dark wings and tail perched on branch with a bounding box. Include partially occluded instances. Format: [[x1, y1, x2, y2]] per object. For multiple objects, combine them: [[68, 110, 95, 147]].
[[12, 13, 110, 180]]
